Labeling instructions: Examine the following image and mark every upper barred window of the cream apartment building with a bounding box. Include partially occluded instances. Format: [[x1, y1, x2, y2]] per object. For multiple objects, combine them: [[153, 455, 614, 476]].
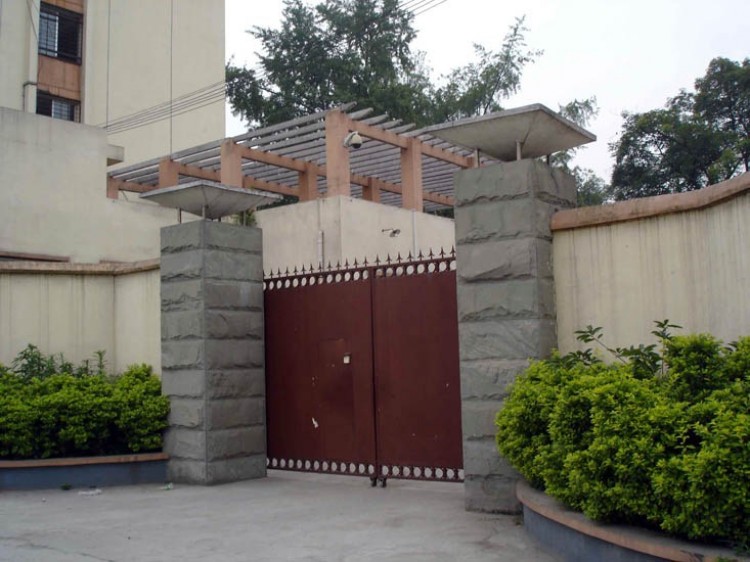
[[39, 2, 83, 64]]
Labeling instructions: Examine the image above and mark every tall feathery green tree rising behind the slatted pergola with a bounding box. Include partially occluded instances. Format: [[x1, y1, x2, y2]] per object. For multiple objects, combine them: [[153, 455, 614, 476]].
[[226, 0, 541, 126]]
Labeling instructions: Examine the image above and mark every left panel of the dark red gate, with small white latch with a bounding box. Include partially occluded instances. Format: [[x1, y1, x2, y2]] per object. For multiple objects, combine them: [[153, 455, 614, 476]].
[[265, 275, 375, 472]]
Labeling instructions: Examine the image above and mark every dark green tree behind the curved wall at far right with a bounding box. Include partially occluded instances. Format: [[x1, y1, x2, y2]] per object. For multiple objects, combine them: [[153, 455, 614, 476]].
[[610, 58, 750, 200]]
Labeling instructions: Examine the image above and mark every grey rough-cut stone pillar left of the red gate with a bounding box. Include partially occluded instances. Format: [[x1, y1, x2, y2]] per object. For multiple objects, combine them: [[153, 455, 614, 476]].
[[161, 221, 266, 484]]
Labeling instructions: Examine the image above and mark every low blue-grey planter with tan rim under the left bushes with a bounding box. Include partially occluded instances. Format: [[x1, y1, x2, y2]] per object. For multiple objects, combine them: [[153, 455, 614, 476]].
[[0, 453, 169, 490]]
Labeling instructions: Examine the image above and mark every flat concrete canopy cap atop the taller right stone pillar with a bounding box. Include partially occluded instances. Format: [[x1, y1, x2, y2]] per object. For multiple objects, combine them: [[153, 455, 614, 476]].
[[423, 103, 596, 161]]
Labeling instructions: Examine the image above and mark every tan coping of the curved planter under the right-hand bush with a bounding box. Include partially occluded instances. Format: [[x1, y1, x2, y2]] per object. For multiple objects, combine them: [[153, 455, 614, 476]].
[[516, 480, 750, 562]]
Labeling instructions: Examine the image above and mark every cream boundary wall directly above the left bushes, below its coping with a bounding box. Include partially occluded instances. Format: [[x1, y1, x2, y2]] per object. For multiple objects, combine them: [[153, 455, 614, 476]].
[[0, 270, 161, 372]]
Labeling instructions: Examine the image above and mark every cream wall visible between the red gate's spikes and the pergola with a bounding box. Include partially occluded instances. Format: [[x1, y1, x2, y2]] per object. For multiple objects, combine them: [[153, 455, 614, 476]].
[[256, 197, 455, 271]]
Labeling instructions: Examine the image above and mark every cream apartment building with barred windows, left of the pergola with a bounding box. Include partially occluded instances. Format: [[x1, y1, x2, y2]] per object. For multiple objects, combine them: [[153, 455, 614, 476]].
[[0, 0, 224, 262]]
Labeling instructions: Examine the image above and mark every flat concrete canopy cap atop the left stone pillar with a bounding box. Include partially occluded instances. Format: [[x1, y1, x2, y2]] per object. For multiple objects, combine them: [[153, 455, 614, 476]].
[[141, 180, 281, 219]]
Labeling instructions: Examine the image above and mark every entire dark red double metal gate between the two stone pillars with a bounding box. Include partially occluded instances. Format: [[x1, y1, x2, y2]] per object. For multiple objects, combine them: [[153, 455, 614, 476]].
[[265, 255, 463, 483]]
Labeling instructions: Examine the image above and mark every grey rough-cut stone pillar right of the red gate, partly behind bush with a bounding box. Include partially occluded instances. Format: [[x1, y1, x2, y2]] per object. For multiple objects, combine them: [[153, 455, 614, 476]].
[[455, 160, 576, 512]]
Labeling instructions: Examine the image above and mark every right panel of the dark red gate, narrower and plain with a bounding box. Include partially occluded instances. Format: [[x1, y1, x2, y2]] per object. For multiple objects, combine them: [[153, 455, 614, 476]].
[[373, 261, 463, 480]]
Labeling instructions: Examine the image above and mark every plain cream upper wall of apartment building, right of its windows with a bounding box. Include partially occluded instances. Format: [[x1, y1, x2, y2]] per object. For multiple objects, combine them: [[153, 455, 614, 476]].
[[83, 0, 225, 165]]
